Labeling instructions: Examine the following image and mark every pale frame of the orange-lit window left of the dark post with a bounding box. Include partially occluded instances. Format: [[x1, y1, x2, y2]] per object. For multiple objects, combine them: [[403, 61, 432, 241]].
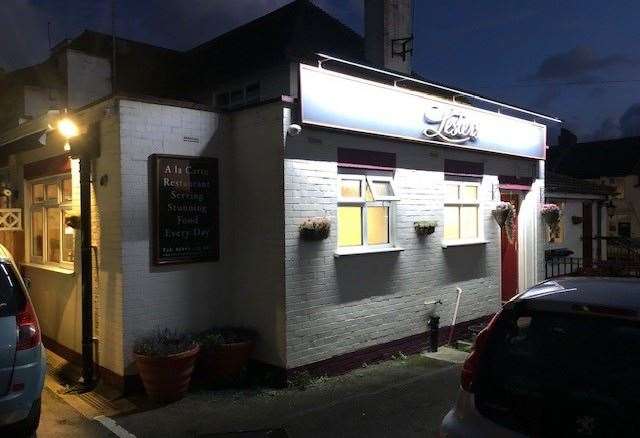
[[25, 173, 77, 271]]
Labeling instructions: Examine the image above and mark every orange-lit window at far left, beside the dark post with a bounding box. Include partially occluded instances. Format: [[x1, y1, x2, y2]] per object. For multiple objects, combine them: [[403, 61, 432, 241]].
[[28, 174, 75, 269]]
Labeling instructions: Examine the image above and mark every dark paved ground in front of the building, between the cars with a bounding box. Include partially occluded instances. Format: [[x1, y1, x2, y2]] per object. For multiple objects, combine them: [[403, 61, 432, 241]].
[[114, 356, 459, 438]]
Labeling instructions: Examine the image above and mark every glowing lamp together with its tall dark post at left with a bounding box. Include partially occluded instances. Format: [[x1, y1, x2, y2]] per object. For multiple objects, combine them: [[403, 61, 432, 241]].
[[57, 116, 96, 389]]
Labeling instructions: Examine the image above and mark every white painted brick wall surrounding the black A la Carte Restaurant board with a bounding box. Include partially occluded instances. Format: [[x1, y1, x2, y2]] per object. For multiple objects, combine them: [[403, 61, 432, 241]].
[[119, 100, 230, 373]]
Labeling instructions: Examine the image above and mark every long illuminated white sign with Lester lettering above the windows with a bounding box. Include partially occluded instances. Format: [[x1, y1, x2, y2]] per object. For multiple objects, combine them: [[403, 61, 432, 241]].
[[300, 64, 546, 159]]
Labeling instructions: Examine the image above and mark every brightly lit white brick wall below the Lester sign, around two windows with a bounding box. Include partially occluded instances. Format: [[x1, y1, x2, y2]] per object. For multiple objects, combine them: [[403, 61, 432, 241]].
[[284, 128, 539, 368]]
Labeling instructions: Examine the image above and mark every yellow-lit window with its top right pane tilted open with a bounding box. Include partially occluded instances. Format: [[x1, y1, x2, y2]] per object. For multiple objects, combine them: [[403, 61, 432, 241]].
[[338, 174, 398, 247]]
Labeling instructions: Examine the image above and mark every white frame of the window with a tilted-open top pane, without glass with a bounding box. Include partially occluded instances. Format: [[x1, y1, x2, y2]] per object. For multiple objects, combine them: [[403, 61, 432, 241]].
[[336, 171, 400, 253]]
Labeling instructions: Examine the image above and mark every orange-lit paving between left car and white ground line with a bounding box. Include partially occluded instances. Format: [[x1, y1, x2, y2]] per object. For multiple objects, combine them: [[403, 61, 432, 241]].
[[36, 388, 115, 438]]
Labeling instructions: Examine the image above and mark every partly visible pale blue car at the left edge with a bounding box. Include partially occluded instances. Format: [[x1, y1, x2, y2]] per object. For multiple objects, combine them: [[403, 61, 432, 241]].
[[0, 245, 46, 436]]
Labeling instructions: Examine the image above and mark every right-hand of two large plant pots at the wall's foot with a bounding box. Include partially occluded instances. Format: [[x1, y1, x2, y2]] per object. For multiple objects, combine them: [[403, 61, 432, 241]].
[[198, 341, 255, 384]]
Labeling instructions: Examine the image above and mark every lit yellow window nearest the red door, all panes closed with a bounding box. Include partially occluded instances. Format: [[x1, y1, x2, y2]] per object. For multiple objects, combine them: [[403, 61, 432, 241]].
[[444, 181, 482, 241]]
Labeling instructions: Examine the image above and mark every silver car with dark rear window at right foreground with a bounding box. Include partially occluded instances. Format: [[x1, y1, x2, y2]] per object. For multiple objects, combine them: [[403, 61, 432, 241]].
[[440, 277, 640, 438]]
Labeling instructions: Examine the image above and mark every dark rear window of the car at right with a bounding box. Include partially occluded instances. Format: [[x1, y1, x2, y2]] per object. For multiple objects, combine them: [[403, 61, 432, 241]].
[[476, 312, 640, 435]]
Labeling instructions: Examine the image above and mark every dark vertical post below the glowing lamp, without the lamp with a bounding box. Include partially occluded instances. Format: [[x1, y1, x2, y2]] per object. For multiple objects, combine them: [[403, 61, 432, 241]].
[[80, 157, 93, 386]]
